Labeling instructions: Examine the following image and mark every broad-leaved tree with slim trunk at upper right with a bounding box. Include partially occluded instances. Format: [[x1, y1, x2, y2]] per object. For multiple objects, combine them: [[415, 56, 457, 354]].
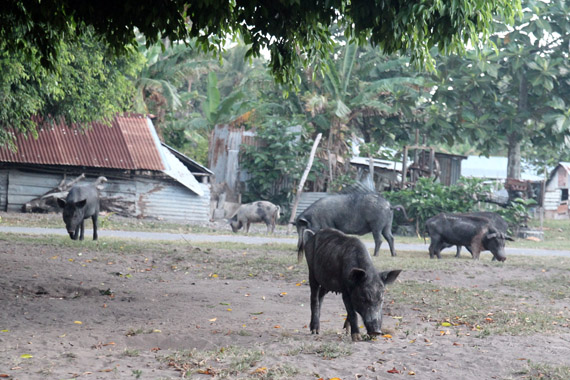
[[426, 0, 570, 178]]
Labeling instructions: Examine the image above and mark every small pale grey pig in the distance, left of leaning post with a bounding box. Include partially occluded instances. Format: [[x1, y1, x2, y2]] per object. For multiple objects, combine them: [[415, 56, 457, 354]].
[[230, 201, 281, 234]]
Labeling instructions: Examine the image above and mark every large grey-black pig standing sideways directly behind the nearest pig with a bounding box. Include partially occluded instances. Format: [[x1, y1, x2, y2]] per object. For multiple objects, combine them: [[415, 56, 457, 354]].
[[295, 192, 407, 262]]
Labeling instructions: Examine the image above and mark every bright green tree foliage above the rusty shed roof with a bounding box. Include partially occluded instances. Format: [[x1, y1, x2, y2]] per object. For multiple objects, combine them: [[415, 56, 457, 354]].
[[0, 30, 143, 146]]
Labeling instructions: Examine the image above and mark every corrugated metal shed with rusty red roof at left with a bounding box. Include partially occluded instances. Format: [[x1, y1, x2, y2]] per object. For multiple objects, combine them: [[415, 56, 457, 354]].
[[0, 114, 212, 223]]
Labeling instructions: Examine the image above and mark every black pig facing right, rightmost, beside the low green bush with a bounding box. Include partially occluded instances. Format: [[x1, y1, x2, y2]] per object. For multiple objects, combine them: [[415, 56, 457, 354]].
[[426, 213, 512, 261]]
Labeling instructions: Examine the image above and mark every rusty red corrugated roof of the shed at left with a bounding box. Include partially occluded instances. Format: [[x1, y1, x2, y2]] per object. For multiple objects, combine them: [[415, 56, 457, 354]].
[[0, 114, 165, 170]]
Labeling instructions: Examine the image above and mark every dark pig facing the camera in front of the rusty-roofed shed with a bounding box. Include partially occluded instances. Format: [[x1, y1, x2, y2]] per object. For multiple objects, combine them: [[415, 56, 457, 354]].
[[57, 181, 106, 240]]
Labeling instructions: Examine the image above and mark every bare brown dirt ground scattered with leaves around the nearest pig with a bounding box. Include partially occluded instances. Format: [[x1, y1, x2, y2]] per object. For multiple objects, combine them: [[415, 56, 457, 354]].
[[0, 227, 570, 380]]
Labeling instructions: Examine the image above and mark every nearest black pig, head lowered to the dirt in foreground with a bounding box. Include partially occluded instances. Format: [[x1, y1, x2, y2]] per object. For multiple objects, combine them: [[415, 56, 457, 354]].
[[303, 228, 401, 341]]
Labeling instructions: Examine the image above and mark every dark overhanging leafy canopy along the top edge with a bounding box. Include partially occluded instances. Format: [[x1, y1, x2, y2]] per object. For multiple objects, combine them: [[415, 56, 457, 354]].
[[0, 0, 520, 83]]
